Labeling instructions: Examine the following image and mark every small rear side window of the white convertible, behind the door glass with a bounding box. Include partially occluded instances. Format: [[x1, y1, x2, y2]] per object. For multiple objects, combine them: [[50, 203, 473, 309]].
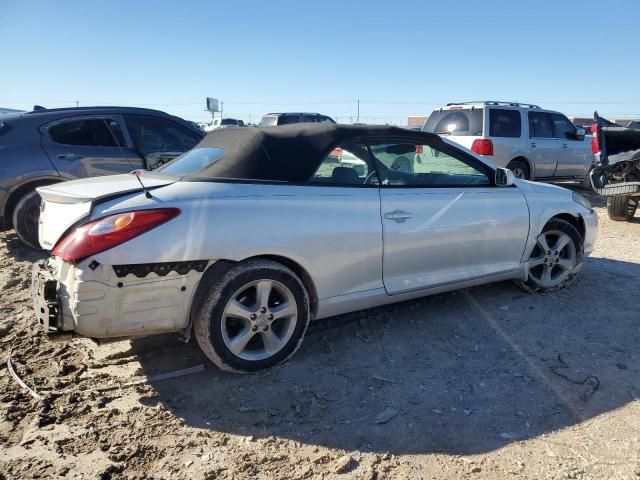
[[309, 143, 377, 186]]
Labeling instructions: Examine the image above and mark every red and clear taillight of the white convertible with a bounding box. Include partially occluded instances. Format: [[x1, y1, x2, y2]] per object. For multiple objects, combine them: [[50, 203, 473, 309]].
[[52, 208, 180, 262]]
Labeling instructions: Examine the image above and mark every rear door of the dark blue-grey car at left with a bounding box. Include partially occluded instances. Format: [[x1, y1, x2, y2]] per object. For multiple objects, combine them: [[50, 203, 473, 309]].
[[41, 115, 144, 178]]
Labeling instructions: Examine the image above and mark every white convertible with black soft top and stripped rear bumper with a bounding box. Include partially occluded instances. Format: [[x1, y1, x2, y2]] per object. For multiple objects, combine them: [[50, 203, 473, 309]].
[[33, 124, 597, 372]]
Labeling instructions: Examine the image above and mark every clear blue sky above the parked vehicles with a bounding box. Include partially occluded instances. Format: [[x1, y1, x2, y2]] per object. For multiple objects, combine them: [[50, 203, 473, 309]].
[[0, 0, 640, 123]]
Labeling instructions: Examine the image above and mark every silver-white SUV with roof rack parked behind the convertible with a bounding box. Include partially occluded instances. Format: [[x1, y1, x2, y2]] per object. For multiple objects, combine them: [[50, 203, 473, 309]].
[[422, 101, 594, 185]]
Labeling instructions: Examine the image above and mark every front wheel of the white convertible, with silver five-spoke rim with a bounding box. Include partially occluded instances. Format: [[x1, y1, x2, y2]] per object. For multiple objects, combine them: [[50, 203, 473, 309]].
[[525, 219, 584, 293]]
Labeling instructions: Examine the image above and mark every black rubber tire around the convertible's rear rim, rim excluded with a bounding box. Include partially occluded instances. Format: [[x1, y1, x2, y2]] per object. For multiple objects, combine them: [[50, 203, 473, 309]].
[[194, 259, 310, 373]]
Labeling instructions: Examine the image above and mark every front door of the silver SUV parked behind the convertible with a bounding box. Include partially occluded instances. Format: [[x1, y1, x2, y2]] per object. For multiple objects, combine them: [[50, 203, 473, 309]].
[[550, 113, 593, 177]]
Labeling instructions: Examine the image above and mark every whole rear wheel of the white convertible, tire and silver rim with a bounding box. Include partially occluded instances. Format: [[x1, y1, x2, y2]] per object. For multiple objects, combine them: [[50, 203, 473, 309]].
[[194, 259, 310, 373]]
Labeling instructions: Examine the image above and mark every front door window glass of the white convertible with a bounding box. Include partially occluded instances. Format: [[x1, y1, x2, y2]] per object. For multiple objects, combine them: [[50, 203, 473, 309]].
[[371, 141, 491, 188]]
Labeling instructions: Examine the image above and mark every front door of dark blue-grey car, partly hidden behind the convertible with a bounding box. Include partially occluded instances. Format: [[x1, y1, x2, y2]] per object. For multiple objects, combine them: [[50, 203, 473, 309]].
[[125, 114, 202, 170]]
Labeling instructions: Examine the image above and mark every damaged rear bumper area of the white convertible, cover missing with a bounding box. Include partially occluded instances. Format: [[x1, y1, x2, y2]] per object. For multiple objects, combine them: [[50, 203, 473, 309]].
[[32, 257, 208, 340]]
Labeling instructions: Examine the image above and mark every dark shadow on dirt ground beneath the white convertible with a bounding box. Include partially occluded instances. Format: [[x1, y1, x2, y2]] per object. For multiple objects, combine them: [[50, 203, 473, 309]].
[[127, 258, 640, 454]]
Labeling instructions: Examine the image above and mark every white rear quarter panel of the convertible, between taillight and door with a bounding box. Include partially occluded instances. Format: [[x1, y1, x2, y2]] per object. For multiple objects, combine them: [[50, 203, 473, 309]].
[[92, 182, 382, 299]]
